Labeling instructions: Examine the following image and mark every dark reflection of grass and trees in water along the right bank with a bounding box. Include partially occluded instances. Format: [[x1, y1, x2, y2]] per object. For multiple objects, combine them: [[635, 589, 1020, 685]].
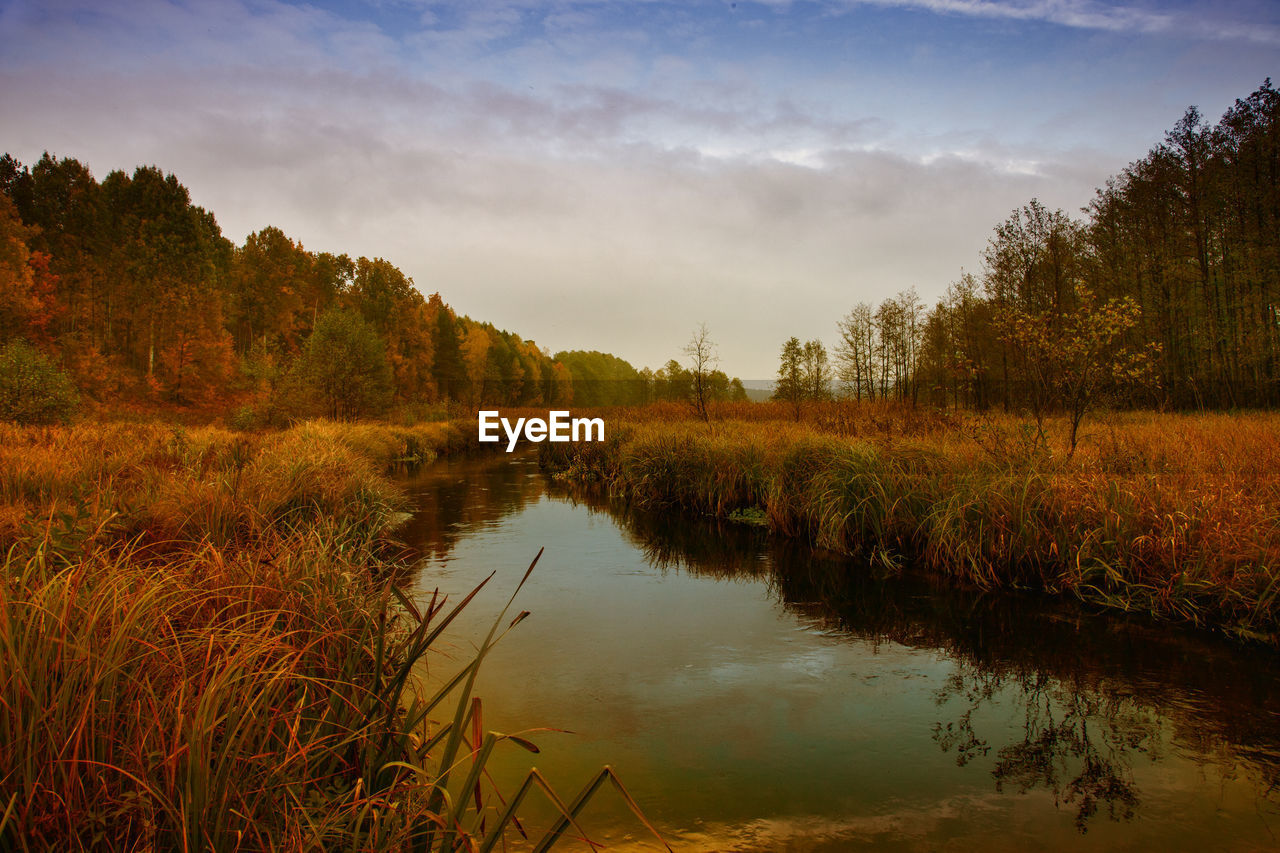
[[577, 484, 1280, 833]]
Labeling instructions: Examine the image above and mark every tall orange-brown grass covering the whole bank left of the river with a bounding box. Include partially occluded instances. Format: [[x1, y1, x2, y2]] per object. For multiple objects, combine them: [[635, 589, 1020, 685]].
[[0, 423, 670, 850]]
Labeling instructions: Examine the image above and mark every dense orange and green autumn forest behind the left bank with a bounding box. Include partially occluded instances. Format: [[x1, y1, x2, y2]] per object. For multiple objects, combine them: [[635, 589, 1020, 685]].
[[0, 152, 741, 420]]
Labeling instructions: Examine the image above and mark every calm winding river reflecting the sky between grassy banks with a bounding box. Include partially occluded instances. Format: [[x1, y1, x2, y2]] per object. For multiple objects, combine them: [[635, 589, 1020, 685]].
[[402, 455, 1280, 850]]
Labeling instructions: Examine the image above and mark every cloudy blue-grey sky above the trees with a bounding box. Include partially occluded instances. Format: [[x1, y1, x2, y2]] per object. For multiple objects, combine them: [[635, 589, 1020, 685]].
[[0, 0, 1280, 379]]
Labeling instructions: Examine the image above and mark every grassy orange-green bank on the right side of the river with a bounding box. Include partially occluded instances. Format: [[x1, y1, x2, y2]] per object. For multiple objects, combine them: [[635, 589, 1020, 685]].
[[541, 405, 1280, 637]]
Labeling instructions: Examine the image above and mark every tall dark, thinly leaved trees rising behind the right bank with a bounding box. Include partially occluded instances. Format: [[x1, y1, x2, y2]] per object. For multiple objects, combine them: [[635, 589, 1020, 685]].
[[776, 78, 1280, 424]]
